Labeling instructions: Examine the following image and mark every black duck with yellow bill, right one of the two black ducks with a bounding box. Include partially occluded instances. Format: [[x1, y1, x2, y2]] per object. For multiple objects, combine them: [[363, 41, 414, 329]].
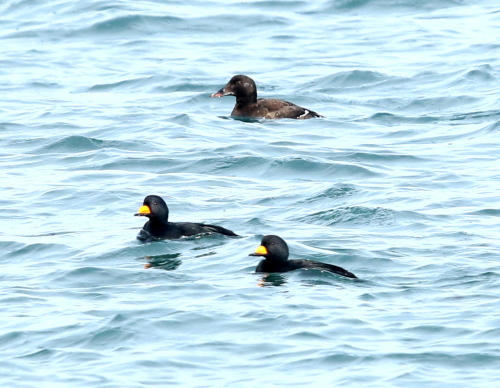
[[249, 235, 357, 279]]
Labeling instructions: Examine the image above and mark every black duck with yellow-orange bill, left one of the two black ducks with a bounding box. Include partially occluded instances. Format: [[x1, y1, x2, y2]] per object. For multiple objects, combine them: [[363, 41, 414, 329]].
[[135, 195, 237, 241]]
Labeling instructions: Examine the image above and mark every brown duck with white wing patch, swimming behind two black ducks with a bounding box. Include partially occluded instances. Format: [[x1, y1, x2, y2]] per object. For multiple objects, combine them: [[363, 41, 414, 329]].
[[210, 75, 323, 120]]
